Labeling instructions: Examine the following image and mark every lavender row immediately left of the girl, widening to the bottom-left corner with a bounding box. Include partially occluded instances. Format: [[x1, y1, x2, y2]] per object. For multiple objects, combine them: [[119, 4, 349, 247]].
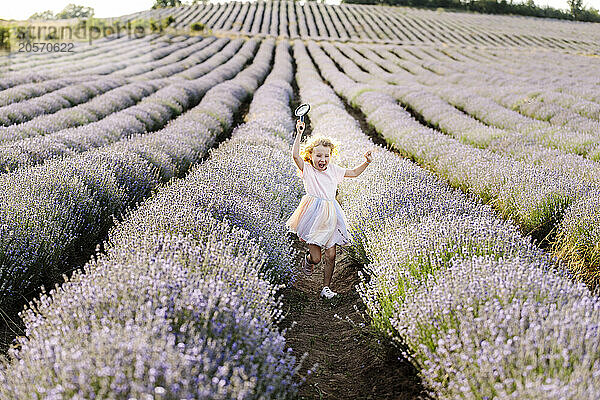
[[0, 42, 302, 399]]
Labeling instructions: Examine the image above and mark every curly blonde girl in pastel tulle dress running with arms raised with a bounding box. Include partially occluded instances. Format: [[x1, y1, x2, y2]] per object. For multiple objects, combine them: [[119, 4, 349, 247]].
[[285, 120, 372, 299]]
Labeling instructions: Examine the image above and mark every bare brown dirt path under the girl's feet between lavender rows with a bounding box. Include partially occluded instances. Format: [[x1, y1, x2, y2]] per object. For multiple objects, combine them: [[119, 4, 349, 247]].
[[280, 242, 426, 399]]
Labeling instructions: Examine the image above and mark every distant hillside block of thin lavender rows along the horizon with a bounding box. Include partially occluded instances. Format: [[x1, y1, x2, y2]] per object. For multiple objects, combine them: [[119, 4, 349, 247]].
[[120, 1, 597, 50]]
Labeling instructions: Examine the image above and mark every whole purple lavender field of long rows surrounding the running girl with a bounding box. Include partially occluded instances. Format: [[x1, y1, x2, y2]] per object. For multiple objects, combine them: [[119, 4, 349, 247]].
[[0, 1, 600, 399]]
